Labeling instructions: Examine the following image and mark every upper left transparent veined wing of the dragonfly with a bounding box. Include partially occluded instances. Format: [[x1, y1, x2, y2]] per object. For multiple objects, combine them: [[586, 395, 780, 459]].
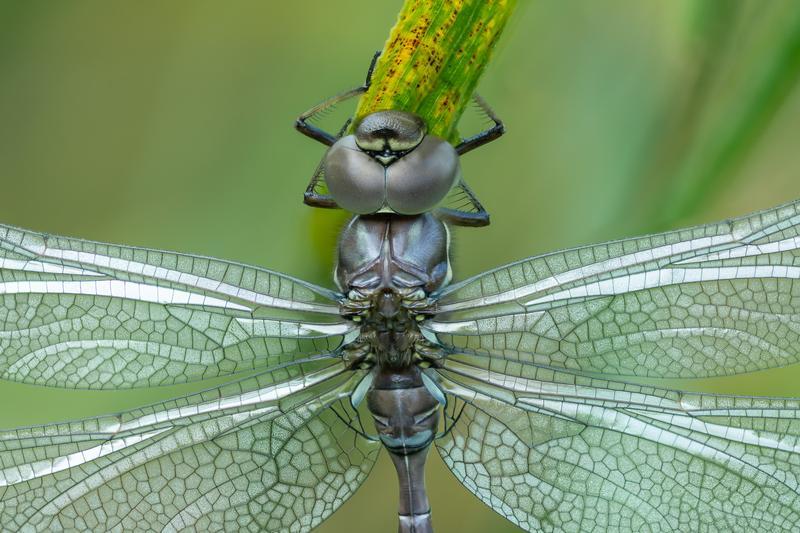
[[0, 222, 355, 389]]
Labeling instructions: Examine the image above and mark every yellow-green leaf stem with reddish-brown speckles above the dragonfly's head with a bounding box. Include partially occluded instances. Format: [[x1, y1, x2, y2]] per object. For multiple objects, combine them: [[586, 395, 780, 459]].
[[356, 0, 517, 142]]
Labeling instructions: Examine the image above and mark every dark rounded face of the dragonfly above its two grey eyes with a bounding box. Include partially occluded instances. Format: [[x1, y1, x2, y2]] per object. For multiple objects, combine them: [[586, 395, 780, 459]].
[[355, 110, 425, 155]]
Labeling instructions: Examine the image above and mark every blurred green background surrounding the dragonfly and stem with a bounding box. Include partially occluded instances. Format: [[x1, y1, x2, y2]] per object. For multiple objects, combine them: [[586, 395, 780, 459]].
[[0, 0, 800, 533]]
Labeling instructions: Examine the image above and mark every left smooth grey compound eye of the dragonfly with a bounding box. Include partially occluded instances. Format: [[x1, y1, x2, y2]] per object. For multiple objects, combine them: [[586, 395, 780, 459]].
[[323, 135, 385, 215]]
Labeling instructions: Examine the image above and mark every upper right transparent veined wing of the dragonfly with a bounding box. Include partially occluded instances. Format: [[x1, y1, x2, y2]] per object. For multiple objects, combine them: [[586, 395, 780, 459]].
[[423, 202, 800, 378]]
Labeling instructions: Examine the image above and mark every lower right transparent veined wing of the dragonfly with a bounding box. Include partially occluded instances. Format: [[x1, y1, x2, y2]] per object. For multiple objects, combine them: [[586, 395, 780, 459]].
[[437, 356, 800, 532]]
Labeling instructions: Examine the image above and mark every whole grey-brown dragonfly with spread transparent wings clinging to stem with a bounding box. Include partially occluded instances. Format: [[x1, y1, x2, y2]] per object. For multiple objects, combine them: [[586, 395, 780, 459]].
[[0, 56, 800, 532]]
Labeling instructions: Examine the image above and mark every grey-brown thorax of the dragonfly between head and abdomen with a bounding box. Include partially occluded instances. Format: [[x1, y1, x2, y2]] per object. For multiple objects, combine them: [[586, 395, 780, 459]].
[[335, 214, 451, 368]]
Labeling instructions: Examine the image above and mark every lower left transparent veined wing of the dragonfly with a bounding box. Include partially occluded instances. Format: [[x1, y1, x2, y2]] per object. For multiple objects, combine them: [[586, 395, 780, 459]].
[[0, 358, 379, 531]]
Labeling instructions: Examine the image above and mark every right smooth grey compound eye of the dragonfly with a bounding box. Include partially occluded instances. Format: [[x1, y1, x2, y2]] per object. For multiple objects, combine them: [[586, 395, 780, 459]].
[[386, 135, 461, 215]]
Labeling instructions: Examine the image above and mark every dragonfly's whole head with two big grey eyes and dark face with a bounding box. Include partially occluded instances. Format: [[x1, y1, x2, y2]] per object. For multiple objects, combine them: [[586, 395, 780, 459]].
[[323, 110, 461, 215]]
